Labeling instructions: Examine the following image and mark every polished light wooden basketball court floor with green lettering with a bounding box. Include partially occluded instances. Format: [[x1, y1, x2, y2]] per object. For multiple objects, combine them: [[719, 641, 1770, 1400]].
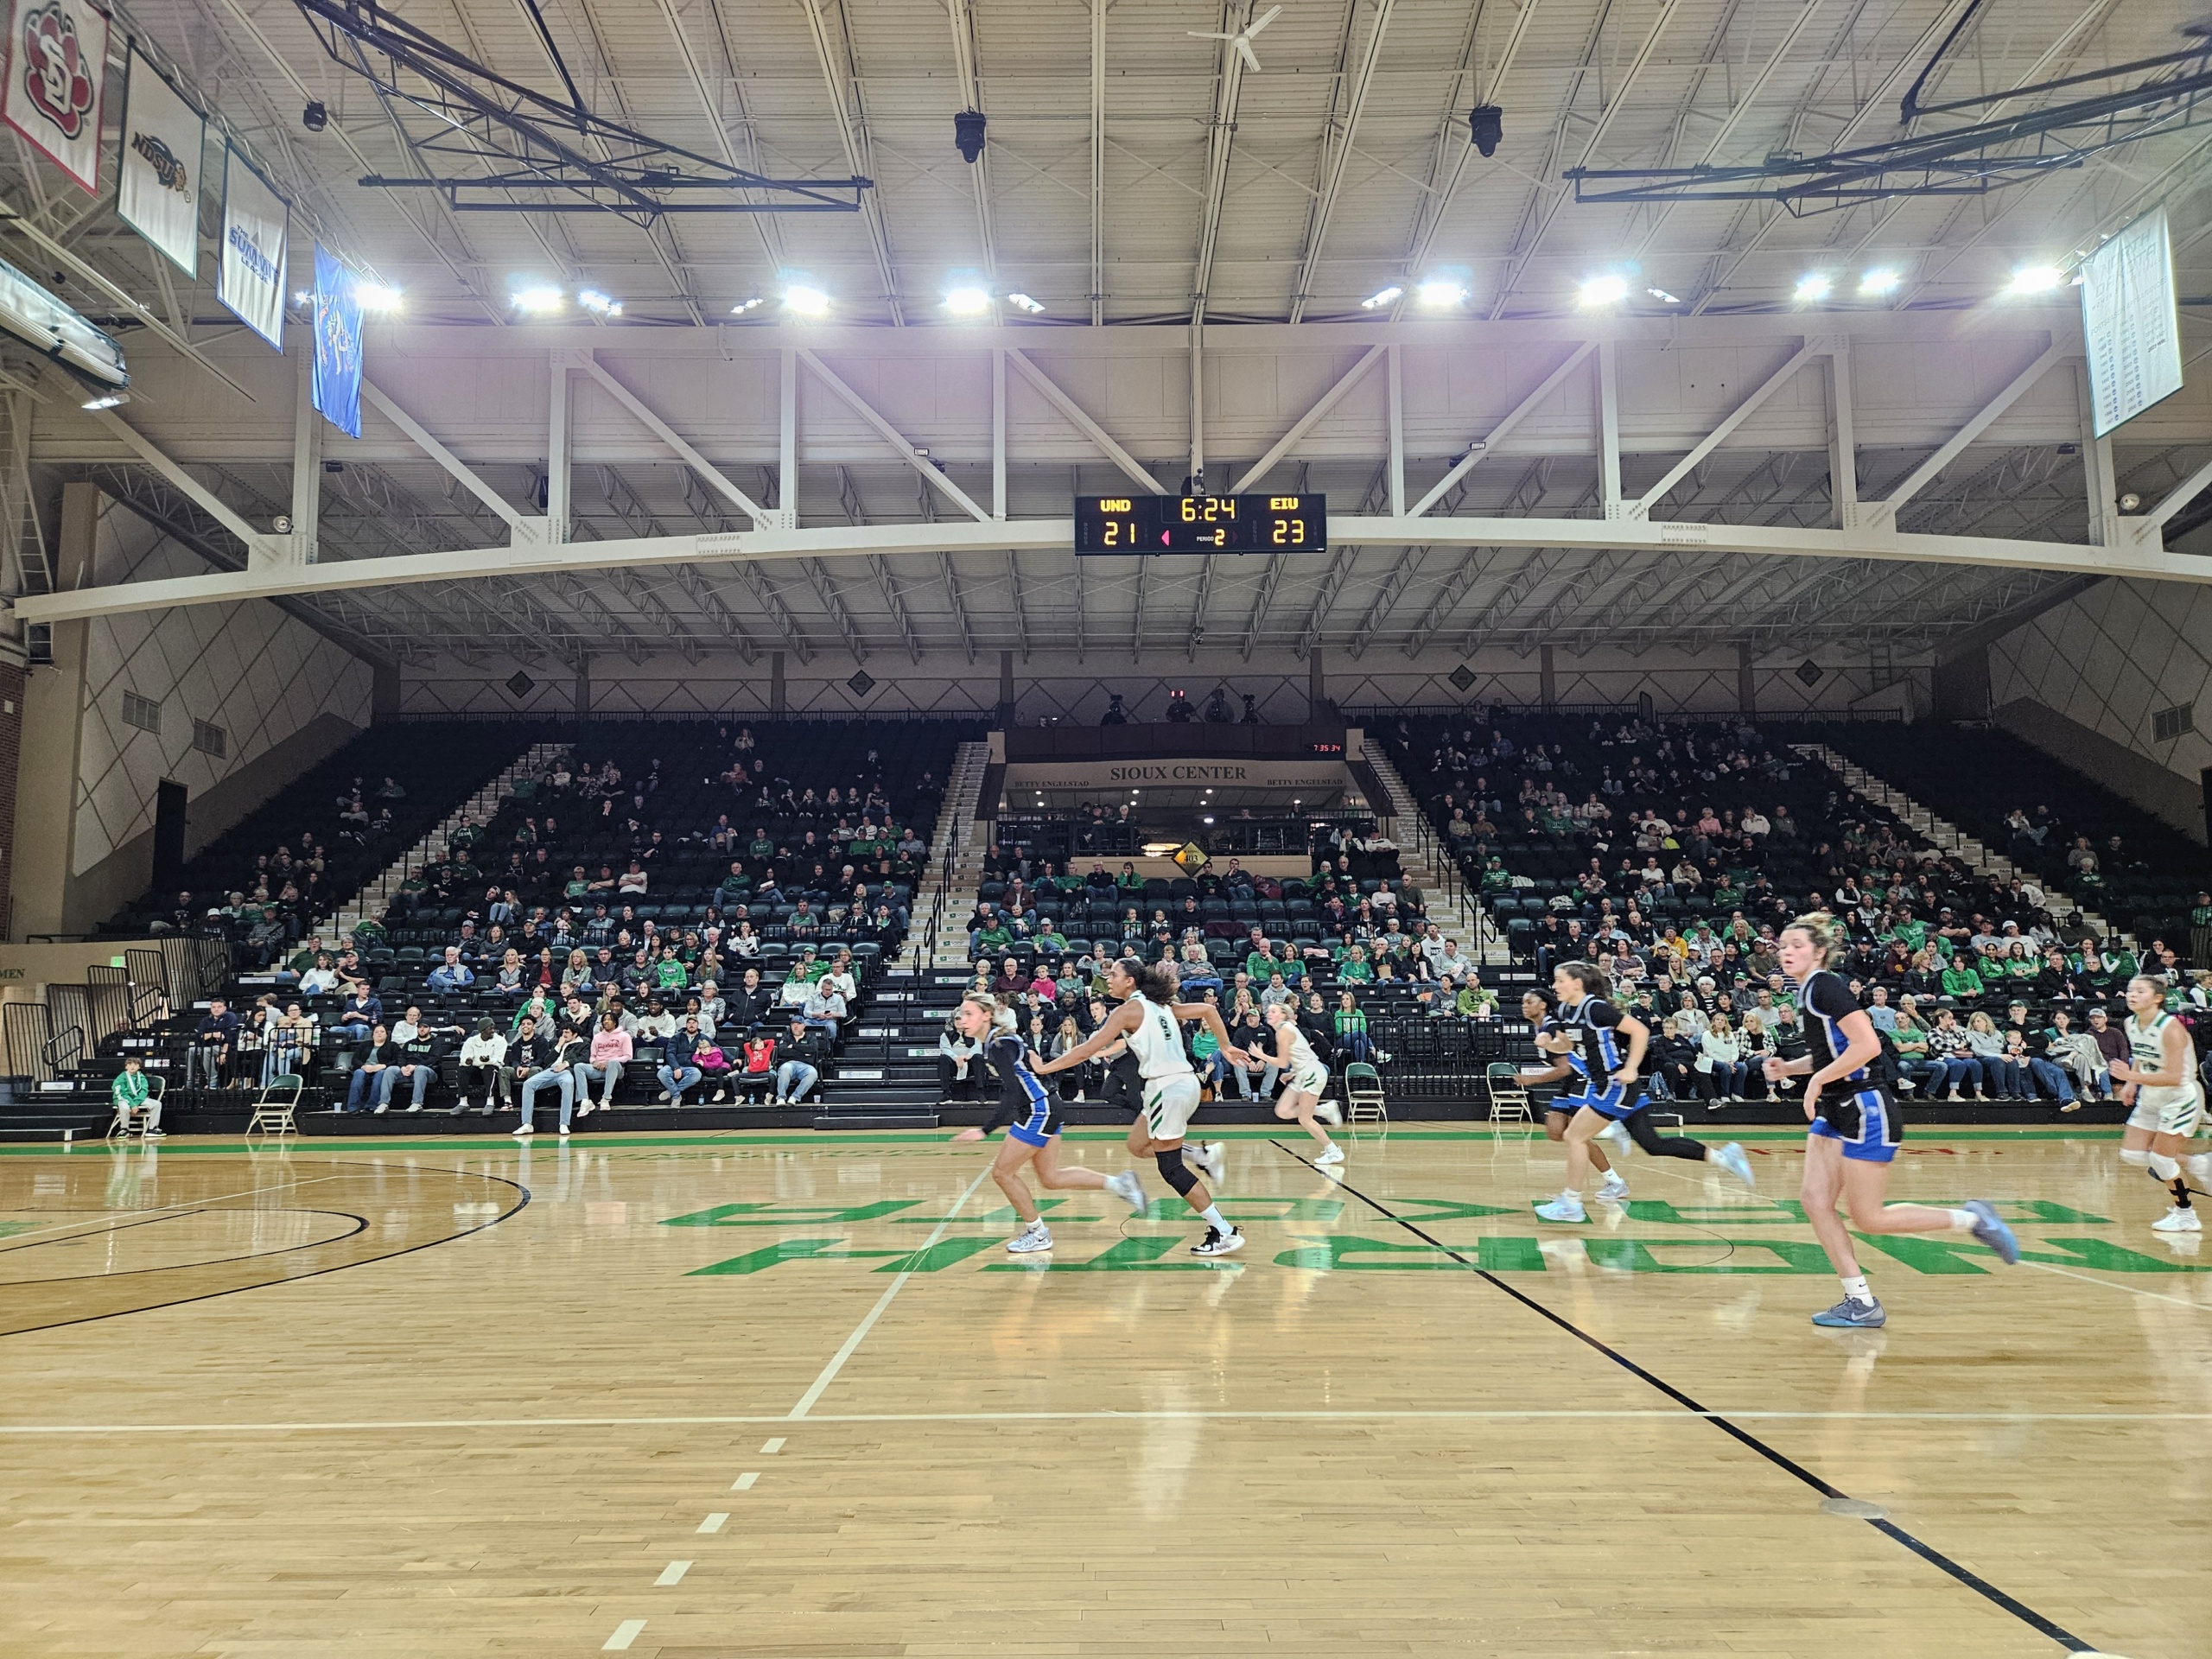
[[0, 1126, 2212, 1659]]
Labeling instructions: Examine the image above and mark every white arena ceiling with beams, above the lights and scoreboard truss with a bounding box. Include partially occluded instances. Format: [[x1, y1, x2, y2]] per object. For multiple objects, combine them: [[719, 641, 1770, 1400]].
[[0, 0, 2212, 661]]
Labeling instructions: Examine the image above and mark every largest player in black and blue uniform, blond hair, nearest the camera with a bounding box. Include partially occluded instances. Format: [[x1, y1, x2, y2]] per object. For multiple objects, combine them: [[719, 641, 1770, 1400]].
[[1765, 912, 2019, 1330]]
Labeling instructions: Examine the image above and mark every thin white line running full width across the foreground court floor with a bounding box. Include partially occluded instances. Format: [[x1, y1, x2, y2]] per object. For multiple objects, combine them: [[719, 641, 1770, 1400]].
[[0, 1407, 2212, 1451]]
